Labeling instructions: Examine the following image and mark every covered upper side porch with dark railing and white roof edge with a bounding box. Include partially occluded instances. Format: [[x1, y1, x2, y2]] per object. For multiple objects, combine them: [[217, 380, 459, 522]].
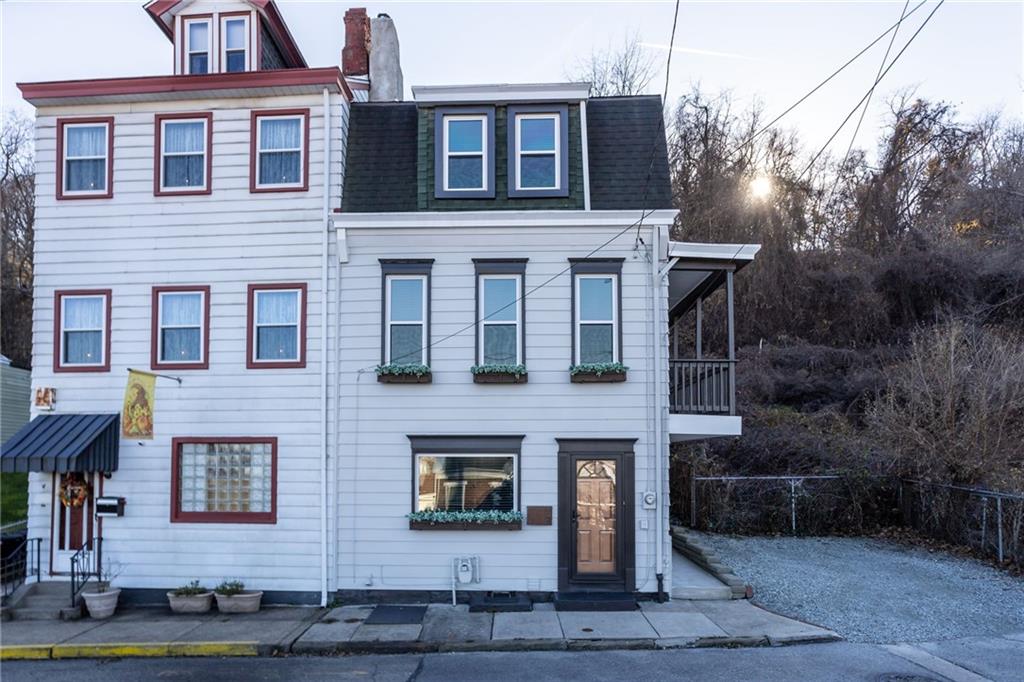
[[668, 242, 761, 441]]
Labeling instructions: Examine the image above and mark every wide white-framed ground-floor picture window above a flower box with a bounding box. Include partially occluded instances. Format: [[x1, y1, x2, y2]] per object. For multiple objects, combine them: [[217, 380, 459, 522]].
[[415, 454, 519, 512]]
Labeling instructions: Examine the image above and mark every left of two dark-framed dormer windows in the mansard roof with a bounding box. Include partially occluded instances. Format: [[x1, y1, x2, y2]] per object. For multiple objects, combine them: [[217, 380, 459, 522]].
[[434, 108, 495, 199]]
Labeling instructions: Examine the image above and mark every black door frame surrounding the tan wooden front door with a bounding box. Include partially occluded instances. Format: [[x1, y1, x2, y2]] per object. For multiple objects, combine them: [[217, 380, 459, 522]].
[[556, 438, 636, 593]]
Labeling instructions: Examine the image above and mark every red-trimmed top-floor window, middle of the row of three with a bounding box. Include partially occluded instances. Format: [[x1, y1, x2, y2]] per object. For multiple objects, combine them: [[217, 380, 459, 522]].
[[153, 112, 213, 197]]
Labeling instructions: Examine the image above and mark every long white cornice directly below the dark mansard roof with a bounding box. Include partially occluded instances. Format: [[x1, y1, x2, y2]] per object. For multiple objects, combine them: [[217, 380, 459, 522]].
[[331, 209, 679, 229]]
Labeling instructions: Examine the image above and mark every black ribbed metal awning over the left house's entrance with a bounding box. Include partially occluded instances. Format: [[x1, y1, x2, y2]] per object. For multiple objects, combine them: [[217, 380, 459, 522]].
[[0, 415, 121, 473]]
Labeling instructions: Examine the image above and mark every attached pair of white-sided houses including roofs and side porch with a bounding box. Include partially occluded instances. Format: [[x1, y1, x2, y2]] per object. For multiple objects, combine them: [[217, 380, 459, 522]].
[[0, 0, 757, 607]]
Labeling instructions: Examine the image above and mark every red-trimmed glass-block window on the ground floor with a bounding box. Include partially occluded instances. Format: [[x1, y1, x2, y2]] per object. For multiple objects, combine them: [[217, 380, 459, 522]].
[[171, 436, 278, 523]]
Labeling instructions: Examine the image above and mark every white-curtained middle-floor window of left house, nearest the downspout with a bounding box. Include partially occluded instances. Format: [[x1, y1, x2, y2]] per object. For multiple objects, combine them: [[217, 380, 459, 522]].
[[252, 289, 304, 364]]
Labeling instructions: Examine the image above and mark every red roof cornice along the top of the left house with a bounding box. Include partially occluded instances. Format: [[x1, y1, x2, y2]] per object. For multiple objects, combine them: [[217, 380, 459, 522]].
[[17, 67, 352, 106]]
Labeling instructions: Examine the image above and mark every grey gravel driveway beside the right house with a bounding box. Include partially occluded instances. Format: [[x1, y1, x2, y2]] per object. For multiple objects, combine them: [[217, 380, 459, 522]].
[[688, 531, 1024, 643]]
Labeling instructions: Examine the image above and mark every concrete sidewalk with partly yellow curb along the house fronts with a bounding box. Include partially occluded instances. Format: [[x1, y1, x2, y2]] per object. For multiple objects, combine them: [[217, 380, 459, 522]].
[[0, 600, 840, 659]]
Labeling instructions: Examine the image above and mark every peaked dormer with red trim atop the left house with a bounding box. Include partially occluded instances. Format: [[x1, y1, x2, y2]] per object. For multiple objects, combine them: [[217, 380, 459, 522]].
[[144, 0, 306, 75]]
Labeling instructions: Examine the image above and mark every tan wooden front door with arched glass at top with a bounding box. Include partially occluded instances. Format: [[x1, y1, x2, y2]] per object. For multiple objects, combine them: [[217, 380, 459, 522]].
[[574, 459, 618, 574]]
